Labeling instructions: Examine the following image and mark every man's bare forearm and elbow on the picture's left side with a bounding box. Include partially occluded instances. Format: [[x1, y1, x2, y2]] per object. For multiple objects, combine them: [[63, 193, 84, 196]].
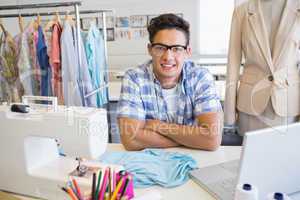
[[118, 117, 179, 151]]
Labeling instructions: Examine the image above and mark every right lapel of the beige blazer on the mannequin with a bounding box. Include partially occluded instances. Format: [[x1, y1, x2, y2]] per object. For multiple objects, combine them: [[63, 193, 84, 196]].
[[272, 0, 300, 66]]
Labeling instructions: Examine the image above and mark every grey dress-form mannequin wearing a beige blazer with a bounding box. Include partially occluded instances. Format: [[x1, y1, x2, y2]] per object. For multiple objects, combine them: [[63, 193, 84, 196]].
[[225, 0, 300, 135]]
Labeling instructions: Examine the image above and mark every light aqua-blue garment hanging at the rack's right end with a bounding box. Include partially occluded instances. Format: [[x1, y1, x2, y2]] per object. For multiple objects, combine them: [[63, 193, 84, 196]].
[[85, 23, 108, 107]]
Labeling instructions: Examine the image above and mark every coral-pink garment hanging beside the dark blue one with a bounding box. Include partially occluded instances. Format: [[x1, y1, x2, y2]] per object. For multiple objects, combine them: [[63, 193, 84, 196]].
[[49, 22, 64, 104]]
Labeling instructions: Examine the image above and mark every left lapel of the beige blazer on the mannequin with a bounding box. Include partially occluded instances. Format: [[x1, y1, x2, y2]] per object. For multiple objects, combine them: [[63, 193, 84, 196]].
[[248, 0, 273, 71]]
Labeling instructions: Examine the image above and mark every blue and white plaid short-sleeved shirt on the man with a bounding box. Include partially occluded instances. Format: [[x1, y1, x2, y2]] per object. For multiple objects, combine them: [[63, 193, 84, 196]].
[[117, 61, 222, 125]]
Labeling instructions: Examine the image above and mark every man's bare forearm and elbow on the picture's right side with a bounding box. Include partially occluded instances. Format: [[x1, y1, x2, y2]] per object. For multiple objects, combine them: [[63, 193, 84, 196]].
[[145, 112, 223, 150]]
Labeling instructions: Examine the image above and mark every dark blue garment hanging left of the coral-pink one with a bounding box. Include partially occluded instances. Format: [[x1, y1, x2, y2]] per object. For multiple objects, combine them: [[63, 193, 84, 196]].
[[36, 26, 52, 96]]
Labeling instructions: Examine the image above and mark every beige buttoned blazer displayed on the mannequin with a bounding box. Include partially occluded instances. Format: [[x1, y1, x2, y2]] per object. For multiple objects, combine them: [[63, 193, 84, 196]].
[[224, 0, 300, 125]]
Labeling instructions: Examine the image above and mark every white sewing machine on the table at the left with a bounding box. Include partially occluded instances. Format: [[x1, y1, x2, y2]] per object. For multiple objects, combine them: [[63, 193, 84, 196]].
[[0, 97, 108, 200]]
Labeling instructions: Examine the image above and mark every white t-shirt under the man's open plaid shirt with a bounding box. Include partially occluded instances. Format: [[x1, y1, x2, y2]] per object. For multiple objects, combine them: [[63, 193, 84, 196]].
[[162, 84, 179, 122]]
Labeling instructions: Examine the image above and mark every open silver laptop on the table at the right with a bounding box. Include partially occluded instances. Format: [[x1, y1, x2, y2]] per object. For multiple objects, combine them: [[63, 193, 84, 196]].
[[190, 123, 300, 200]]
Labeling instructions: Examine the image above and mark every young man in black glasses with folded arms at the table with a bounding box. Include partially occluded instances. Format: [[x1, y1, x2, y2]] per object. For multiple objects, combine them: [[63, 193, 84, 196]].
[[118, 14, 223, 150]]
